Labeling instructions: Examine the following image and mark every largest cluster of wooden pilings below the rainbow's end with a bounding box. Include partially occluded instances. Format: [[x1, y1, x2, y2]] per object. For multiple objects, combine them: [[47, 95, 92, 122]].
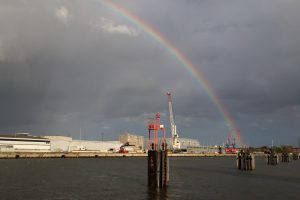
[[236, 150, 255, 171]]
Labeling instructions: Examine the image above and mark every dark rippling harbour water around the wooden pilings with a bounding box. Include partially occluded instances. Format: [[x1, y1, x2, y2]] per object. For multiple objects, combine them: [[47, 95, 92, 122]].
[[0, 157, 300, 200]]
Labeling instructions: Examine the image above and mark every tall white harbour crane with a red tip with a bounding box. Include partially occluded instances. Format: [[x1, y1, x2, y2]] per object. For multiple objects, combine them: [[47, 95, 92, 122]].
[[167, 92, 180, 151]]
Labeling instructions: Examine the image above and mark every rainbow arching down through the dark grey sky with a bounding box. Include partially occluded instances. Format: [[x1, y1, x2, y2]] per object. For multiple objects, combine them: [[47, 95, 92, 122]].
[[101, 0, 242, 146]]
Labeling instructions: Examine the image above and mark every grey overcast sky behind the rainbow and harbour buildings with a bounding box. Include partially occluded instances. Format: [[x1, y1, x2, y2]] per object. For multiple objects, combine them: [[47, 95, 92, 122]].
[[0, 0, 300, 146]]
